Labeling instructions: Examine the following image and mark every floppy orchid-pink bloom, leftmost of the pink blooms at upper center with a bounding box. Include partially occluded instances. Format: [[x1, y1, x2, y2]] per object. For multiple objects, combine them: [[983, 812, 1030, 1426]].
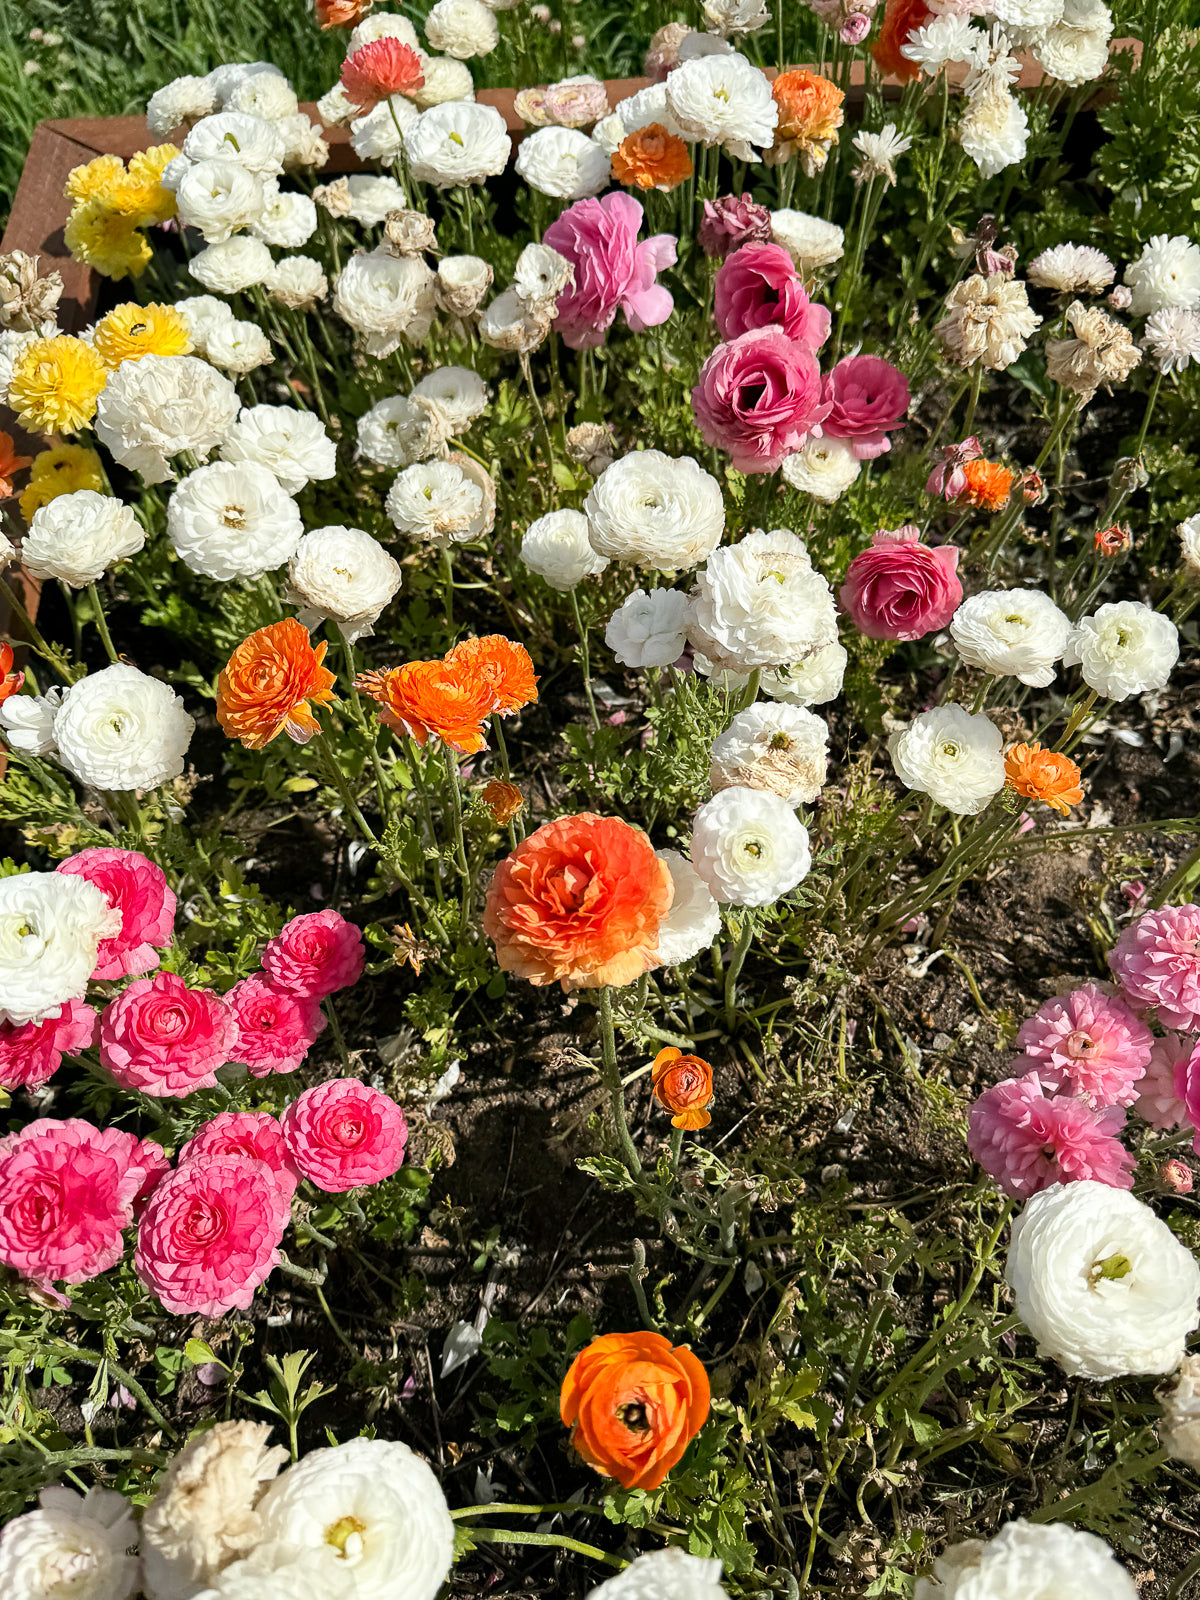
[[542, 194, 675, 350]]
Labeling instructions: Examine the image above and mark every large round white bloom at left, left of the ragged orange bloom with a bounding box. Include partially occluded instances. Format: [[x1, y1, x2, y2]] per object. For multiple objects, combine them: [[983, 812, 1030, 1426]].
[[54, 661, 195, 790]]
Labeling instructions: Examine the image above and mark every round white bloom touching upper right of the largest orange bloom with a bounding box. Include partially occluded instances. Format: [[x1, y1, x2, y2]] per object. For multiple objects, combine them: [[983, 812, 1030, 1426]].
[[691, 786, 813, 906]]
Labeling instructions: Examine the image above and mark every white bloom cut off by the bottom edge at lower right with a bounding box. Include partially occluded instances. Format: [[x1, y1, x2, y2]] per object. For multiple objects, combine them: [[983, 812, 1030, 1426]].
[[917, 1520, 1138, 1600]]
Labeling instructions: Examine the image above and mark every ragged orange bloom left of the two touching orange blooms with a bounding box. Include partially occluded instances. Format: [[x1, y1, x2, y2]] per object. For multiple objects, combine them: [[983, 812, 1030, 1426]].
[[216, 616, 334, 750]]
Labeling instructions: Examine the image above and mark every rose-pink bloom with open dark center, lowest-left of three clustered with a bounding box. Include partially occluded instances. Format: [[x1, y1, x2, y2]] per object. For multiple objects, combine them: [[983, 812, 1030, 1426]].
[[691, 328, 829, 472]]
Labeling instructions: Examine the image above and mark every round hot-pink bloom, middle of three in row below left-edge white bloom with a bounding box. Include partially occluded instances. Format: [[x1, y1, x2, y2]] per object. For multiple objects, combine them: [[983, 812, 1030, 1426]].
[[99, 973, 237, 1098]]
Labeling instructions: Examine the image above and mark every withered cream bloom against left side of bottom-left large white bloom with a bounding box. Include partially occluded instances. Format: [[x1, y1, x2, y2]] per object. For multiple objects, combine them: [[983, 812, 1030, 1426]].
[[141, 1422, 288, 1600]]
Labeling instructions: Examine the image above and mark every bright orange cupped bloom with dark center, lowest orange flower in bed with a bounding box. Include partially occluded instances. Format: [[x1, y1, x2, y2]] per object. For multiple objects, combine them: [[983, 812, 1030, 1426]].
[[558, 1333, 709, 1490]]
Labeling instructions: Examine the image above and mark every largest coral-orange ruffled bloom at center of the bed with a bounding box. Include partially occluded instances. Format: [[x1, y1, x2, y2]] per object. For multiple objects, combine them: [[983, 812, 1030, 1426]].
[[483, 811, 674, 994]]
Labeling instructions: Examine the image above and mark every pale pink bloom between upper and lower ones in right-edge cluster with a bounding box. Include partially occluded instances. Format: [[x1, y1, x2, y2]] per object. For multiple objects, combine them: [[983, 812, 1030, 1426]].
[[1014, 984, 1154, 1106]]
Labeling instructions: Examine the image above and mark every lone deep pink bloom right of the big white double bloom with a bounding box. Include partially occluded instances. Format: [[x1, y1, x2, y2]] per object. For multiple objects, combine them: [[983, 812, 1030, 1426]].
[[838, 523, 963, 642]]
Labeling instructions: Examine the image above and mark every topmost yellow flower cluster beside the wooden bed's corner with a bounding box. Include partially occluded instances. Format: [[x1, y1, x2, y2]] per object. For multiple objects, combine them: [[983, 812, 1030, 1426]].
[[64, 144, 179, 278]]
